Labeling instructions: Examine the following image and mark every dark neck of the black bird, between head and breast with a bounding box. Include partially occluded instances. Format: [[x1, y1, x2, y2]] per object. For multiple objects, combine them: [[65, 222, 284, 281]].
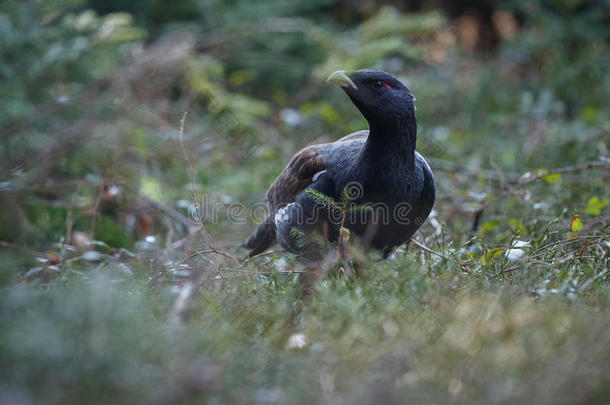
[[362, 112, 417, 170]]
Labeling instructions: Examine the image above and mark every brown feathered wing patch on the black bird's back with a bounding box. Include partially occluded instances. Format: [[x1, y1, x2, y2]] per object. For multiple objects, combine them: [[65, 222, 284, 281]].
[[266, 145, 326, 212]]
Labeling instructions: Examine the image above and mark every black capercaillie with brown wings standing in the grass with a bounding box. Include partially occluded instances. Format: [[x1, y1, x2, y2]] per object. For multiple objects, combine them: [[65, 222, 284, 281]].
[[243, 70, 435, 257]]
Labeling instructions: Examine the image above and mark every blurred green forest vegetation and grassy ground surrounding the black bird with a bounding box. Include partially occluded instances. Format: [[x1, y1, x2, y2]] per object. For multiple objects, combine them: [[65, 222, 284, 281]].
[[0, 0, 610, 404]]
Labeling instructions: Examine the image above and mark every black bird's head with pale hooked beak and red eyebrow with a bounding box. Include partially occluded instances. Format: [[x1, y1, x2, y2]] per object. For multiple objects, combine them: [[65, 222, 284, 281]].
[[326, 70, 415, 126]]
